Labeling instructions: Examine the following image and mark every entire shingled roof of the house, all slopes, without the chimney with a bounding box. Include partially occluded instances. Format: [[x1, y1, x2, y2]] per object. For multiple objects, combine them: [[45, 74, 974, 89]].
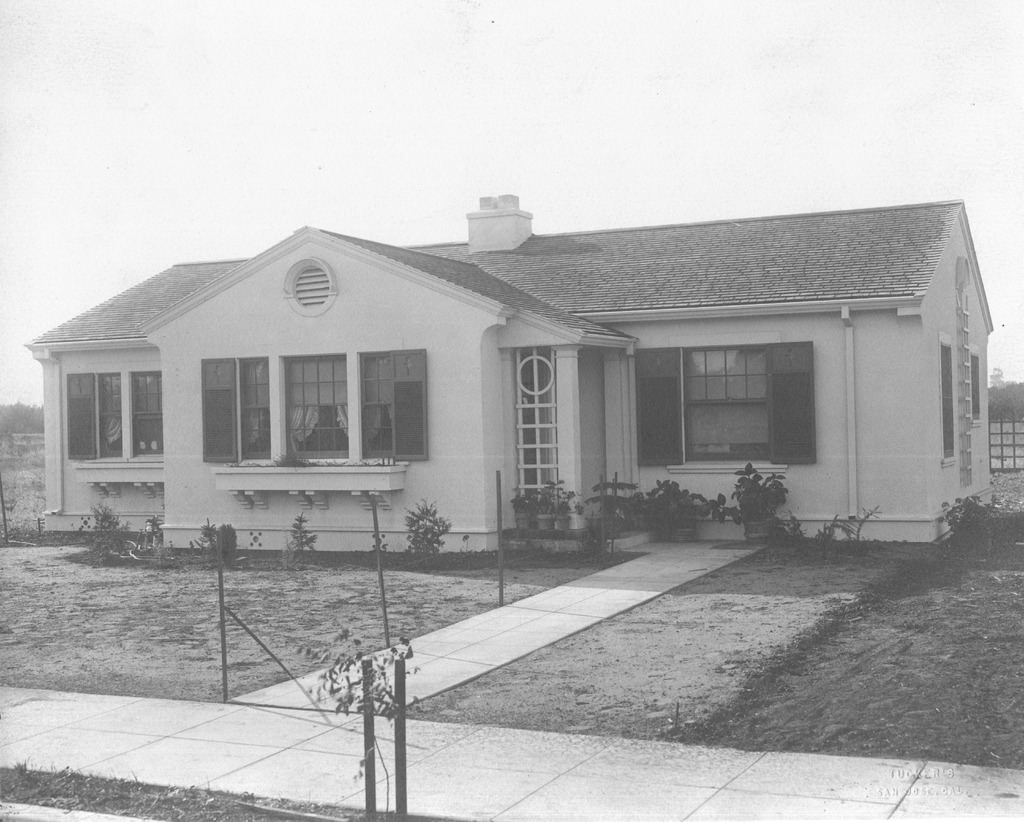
[[33, 201, 964, 345]]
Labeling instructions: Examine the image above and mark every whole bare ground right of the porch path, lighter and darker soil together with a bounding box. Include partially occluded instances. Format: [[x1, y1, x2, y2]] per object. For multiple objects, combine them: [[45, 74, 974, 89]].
[[411, 475, 1024, 769]]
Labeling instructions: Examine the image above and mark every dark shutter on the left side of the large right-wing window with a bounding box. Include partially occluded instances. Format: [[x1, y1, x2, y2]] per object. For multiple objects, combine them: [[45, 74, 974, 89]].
[[636, 348, 683, 464]]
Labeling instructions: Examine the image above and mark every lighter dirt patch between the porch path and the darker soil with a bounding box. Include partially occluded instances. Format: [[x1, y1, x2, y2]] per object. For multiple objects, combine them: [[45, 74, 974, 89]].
[[416, 546, 907, 738]]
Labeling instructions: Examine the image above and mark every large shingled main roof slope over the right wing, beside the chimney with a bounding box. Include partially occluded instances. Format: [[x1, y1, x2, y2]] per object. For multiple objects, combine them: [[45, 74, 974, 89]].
[[420, 201, 964, 314]]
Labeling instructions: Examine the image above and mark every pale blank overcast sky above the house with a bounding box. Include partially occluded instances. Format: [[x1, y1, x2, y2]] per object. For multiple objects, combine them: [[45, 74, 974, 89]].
[[0, 0, 1024, 403]]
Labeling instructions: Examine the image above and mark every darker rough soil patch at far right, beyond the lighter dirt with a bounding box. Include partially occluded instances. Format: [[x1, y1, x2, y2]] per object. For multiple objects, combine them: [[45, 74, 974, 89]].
[[677, 549, 1024, 769]]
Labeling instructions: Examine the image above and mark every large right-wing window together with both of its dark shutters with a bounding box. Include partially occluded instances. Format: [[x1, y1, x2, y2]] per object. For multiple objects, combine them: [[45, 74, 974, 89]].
[[636, 343, 815, 464]]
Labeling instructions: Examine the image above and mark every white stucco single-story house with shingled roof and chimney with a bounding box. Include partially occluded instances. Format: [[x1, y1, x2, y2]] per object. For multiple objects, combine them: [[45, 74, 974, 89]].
[[29, 196, 992, 550]]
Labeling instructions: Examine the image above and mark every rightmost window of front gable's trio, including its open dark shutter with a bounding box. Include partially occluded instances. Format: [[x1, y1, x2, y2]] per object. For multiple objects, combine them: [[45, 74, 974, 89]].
[[359, 351, 427, 460]]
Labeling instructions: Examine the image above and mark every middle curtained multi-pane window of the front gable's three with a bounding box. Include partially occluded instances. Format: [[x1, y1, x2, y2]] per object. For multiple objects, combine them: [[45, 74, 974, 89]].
[[286, 356, 348, 457]]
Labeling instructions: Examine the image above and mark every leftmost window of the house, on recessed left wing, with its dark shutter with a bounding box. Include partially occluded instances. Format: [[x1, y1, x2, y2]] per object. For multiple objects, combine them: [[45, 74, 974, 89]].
[[68, 374, 123, 460]]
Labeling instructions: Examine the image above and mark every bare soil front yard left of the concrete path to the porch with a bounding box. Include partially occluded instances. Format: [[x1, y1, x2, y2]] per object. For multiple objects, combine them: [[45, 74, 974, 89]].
[[0, 547, 618, 700]]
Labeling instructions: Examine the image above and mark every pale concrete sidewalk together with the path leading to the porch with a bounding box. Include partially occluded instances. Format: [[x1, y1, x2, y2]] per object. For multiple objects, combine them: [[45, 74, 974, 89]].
[[0, 544, 1024, 820]]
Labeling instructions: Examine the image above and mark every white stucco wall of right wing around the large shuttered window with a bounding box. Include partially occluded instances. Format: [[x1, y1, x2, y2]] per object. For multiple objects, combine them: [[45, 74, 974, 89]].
[[607, 280, 988, 540]]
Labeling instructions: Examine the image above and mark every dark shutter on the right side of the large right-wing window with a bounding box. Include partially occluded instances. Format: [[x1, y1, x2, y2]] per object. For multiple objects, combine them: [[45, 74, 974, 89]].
[[768, 343, 816, 464]]
